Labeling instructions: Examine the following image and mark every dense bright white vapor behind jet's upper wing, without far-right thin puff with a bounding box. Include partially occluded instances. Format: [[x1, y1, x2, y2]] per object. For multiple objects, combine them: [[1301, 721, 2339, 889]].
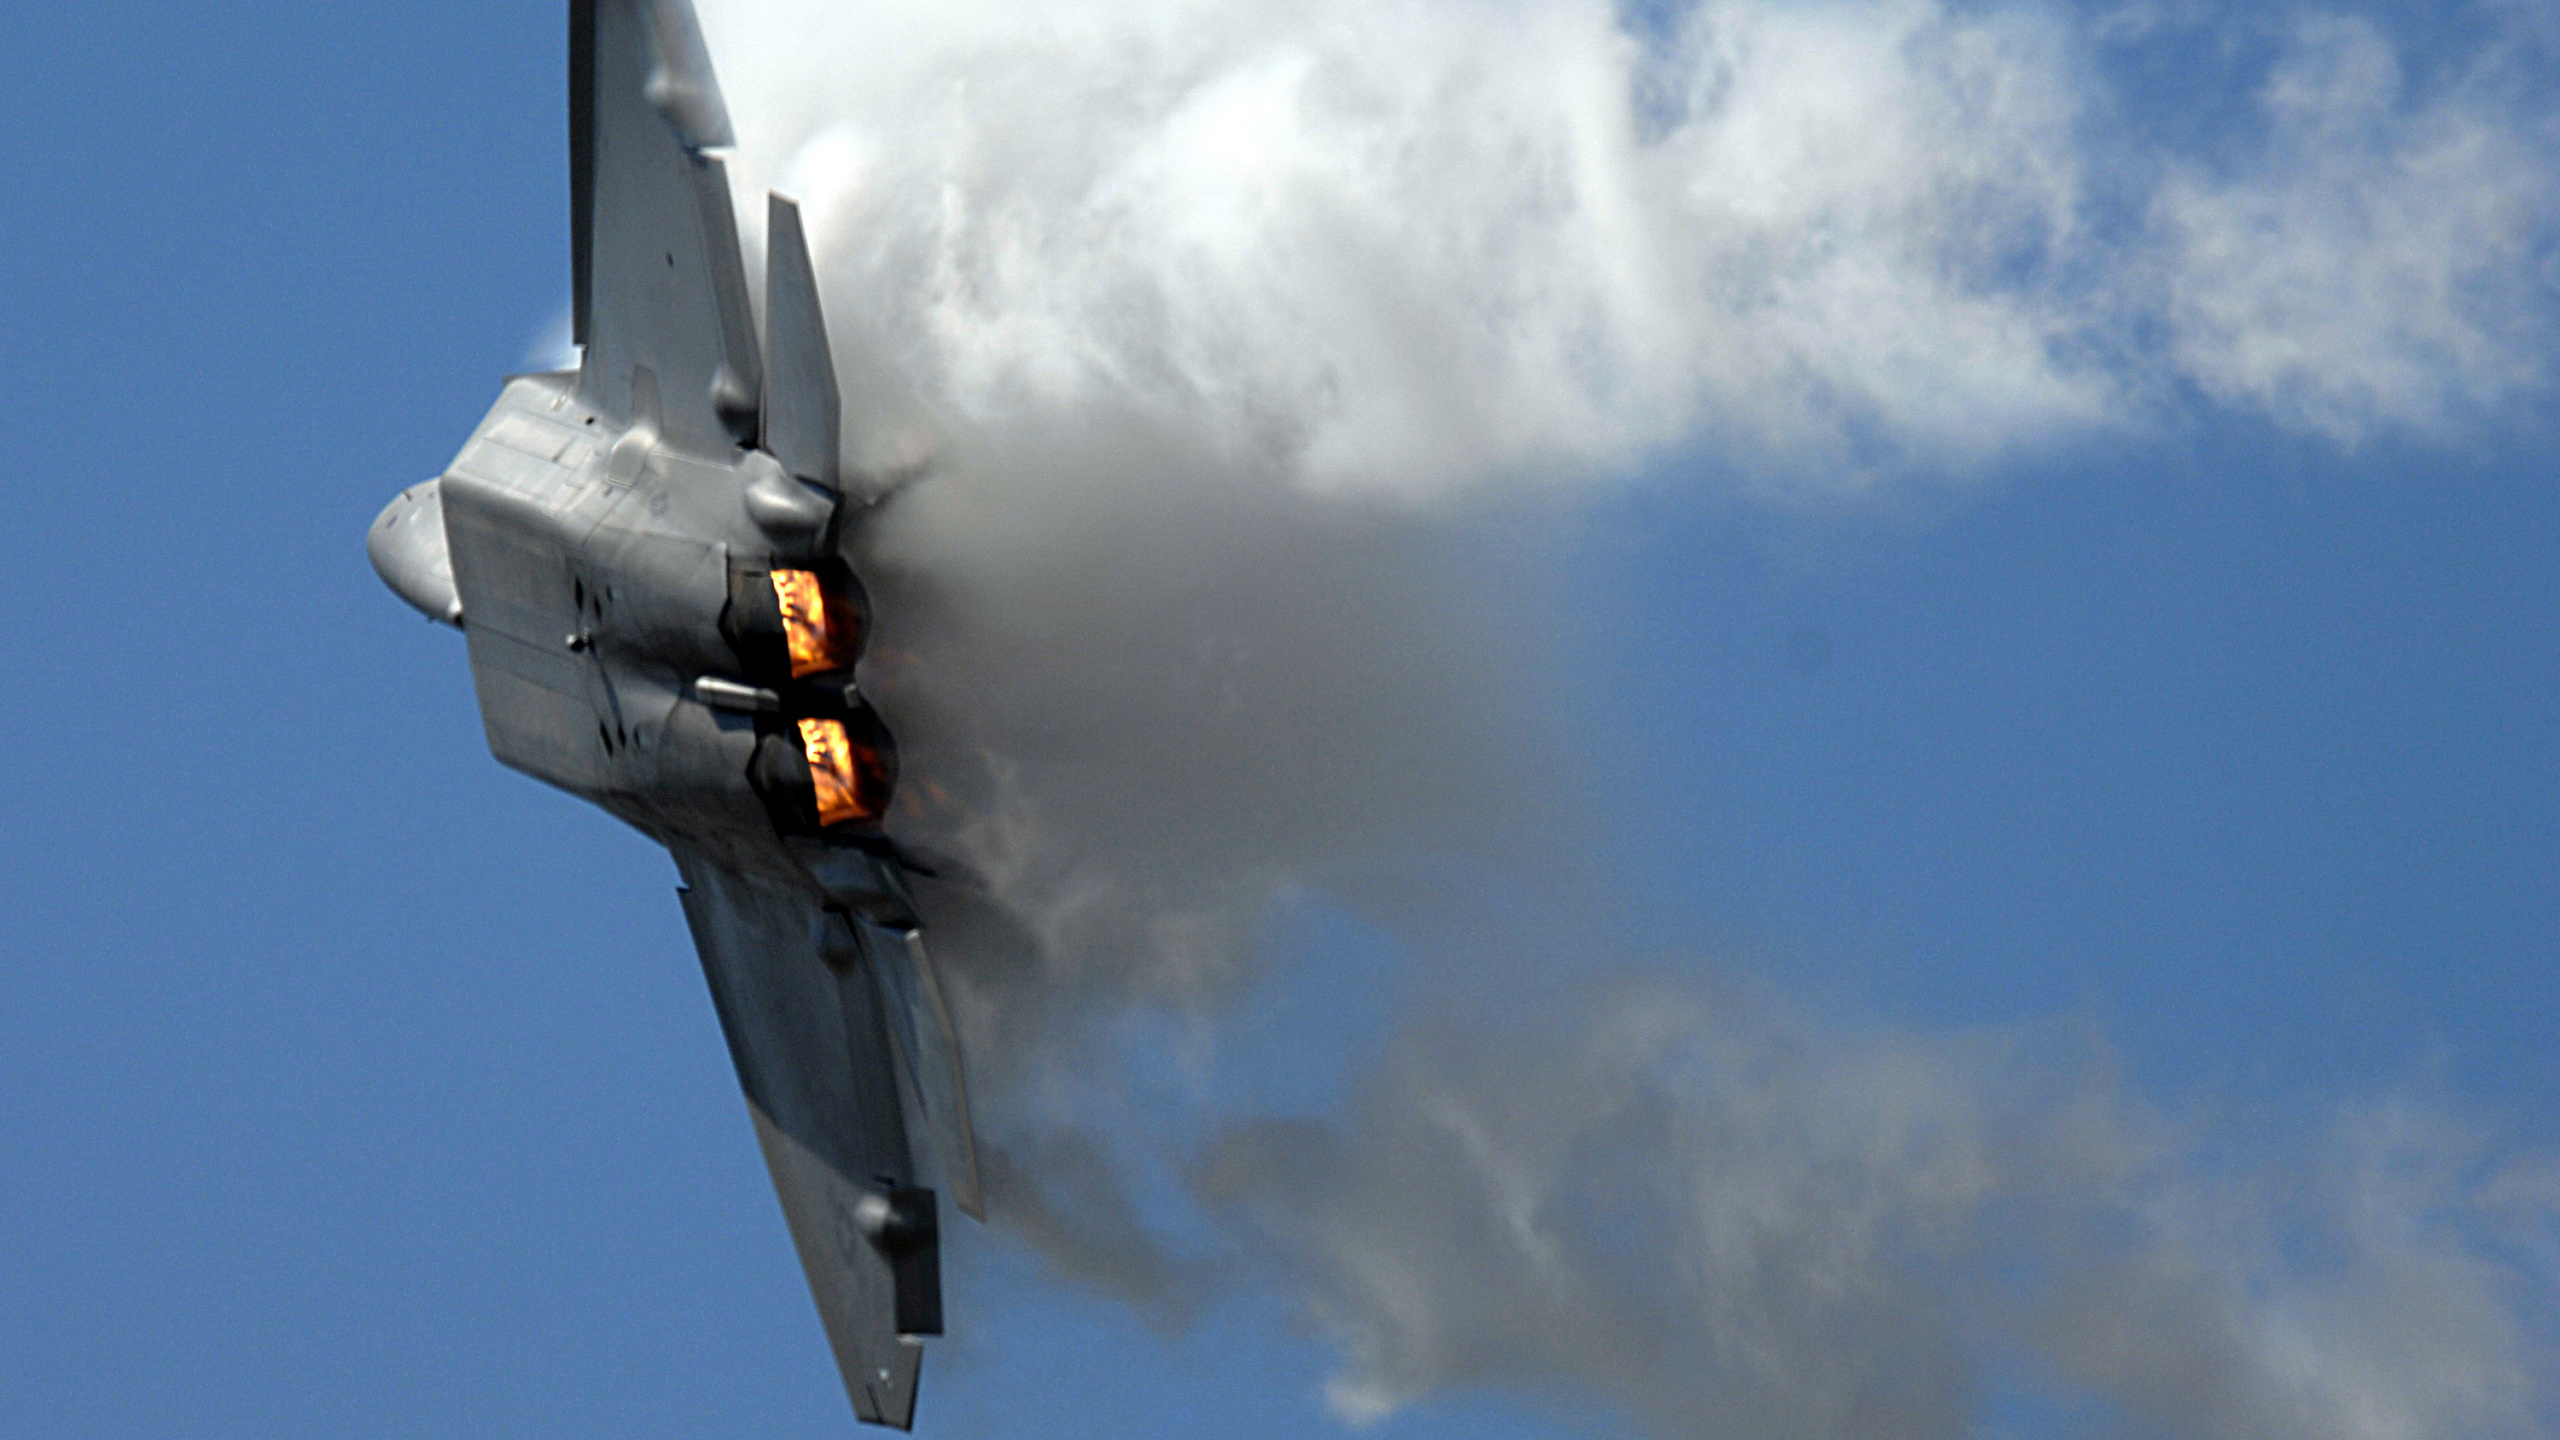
[[691, 0, 2115, 495]]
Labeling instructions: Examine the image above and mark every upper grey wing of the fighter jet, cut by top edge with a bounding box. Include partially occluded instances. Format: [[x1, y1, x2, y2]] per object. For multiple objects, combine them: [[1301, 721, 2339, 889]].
[[583, 0, 763, 459]]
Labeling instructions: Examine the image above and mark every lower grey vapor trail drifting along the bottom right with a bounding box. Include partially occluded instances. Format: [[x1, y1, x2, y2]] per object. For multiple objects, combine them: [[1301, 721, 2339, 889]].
[[1198, 981, 2560, 1440]]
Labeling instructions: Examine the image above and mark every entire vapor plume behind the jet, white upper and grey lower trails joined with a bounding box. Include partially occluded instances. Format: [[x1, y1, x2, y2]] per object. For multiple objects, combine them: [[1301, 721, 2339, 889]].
[[680, 0, 2560, 1437]]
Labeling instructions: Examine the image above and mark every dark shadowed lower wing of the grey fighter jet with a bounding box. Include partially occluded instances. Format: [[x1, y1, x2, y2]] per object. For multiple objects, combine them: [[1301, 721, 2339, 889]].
[[676, 851, 942, 1430]]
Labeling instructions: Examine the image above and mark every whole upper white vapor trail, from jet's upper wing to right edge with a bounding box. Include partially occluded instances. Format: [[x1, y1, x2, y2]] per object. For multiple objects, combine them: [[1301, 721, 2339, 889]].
[[712, 0, 2560, 497]]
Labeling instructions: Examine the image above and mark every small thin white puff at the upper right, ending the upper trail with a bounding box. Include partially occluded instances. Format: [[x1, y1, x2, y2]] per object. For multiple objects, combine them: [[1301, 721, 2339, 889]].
[[2153, 18, 2560, 443]]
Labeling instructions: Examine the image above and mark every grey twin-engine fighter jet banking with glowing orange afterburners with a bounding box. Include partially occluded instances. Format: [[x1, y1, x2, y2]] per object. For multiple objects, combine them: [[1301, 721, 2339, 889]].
[[366, 0, 980, 1430]]
